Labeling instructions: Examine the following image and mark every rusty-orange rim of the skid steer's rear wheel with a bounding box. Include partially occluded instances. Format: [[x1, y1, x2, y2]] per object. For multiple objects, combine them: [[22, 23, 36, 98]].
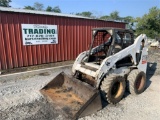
[[135, 75, 144, 91]]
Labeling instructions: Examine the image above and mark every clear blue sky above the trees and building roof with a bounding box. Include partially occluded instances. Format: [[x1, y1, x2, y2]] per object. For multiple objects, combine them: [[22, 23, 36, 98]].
[[10, 0, 160, 17]]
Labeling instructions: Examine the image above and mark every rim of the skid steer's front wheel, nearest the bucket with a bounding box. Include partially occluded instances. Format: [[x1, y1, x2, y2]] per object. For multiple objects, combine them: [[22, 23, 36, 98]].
[[111, 82, 123, 98]]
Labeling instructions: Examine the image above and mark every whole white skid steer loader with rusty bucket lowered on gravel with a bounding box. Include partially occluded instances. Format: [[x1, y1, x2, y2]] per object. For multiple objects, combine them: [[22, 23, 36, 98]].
[[41, 28, 148, 119]]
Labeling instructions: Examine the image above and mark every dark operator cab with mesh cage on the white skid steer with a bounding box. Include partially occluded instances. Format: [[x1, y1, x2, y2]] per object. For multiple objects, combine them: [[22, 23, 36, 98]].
[[87, 28, 134, 65]]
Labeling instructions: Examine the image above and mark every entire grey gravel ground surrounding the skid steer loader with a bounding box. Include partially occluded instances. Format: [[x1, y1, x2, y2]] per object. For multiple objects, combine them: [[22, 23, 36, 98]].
[[0, 49, 160, 120]]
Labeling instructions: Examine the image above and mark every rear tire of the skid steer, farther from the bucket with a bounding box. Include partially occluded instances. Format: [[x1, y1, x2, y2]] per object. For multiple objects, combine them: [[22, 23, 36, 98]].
[[127, 69, 146, 95]]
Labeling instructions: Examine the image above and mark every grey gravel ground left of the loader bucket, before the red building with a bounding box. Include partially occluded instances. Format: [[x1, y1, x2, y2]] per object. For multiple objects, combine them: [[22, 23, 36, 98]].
[[0, 67, 71, 120]]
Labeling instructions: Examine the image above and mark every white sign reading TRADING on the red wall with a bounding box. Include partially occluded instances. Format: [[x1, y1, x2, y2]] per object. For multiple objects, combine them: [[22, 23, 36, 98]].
[[21, 24, 58, 45]]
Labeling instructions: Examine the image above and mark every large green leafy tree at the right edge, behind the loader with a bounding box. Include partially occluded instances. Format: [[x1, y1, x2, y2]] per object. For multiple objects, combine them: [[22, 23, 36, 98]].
[[136, 7, 160, 38]]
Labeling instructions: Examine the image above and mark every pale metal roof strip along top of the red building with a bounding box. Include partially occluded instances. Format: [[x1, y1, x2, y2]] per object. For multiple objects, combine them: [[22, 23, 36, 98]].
[[0, 7, 125, 23]]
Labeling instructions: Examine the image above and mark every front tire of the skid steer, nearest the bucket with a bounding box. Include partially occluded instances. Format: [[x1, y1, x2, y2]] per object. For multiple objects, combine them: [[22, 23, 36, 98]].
[[101, 75, 126, 104]]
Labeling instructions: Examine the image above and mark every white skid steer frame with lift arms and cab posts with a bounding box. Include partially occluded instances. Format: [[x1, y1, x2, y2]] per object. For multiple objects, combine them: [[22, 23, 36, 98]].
[[72, 28, 148, 88]]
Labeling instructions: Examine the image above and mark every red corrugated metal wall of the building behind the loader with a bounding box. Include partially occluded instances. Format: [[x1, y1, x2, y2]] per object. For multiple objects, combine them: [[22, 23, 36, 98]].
[[0, 11, 125, 70]]
